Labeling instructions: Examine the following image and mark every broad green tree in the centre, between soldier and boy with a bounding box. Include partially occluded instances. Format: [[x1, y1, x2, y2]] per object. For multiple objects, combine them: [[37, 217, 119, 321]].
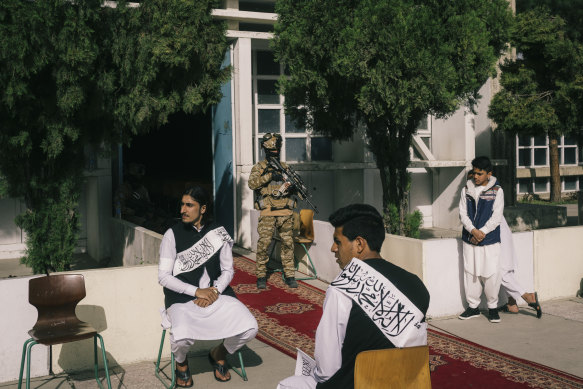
[[274, 0, 512, 231]]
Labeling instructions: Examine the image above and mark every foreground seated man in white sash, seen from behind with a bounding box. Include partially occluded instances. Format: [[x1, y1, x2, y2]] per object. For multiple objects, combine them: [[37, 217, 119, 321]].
[[278, 204, 429, 389]]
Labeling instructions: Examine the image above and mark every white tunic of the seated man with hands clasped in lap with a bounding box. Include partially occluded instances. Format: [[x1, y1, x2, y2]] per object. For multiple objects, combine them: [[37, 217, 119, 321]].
[[158, 229, 257, 341]]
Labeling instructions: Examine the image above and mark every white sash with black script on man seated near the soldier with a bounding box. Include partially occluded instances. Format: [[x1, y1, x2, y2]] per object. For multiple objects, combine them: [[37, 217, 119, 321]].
[[172, 227, 233, 276]]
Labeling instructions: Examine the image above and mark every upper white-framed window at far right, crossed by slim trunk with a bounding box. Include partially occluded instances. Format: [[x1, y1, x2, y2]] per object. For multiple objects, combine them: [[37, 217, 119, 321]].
[[516, 135, 579, 167]]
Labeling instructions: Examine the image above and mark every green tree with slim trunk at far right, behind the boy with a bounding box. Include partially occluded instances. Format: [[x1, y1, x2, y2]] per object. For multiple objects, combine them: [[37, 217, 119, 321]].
[[488, 8, 583, 201]]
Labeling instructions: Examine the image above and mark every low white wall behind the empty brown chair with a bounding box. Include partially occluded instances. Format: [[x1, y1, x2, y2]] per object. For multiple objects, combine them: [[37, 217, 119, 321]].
[[0, 265, 170, 382]]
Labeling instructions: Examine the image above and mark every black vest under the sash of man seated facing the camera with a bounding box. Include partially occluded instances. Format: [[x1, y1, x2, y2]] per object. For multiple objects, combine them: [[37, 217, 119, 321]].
[[164, 222, 236, 309]]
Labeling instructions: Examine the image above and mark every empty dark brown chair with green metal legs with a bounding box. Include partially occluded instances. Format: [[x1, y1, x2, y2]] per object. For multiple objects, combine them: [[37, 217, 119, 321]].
[[18, 274, 111, 389]]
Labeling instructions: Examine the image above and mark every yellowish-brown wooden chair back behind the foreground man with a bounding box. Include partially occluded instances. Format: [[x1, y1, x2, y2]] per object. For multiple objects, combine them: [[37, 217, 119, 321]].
[[354, 346, 431, 389]]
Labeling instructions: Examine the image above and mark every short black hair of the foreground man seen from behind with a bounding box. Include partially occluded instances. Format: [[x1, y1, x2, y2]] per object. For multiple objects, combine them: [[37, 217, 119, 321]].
[[328, 204, 385, 252]]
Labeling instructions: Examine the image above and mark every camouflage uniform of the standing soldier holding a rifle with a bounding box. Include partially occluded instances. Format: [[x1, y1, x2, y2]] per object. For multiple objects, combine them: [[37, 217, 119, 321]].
[[249, 160, 296, 278]]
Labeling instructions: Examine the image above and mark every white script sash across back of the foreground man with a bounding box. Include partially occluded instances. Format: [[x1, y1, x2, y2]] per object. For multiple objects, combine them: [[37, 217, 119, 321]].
[[330, 258, 427, 347]]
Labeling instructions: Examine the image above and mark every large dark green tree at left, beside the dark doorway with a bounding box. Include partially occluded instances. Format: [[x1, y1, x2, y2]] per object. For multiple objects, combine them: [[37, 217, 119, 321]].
[[0, 0, 229, 272]]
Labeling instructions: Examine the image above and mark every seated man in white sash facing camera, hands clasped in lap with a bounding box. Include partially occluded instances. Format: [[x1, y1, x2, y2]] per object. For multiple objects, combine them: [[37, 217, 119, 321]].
[[158, 186, 257, 387]]
